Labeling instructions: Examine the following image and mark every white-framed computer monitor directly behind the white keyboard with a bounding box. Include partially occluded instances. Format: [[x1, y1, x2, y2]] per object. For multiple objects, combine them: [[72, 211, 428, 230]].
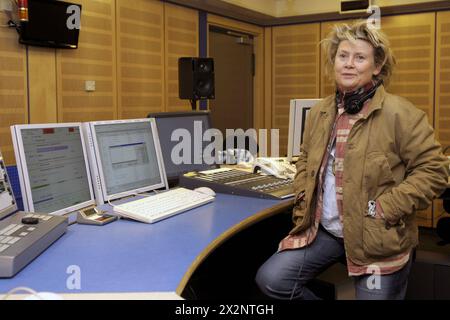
[[83, 119, 168, 205]]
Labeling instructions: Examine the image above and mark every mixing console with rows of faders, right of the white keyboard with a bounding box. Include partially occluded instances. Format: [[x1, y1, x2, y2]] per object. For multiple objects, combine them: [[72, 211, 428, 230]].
[[180, 168, 294, 199]]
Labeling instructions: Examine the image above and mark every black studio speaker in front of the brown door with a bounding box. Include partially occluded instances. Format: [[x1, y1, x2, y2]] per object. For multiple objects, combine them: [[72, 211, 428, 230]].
[[178, 57, 215, 100]]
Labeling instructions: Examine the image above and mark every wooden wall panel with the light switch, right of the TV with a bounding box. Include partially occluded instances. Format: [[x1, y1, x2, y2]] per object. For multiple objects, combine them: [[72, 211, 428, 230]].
[[56, 0, 117, 122]]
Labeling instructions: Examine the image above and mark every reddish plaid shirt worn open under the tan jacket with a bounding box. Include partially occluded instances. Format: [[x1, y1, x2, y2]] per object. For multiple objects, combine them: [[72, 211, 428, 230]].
[[278, 95, 410, 276]]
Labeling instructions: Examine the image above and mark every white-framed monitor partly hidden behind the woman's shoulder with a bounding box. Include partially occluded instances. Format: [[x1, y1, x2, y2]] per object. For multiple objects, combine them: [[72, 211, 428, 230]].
[[287, 99, 321, 161]]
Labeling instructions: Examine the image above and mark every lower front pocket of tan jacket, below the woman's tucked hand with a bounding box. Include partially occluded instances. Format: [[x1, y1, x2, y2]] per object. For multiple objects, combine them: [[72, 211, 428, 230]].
[[363, 216, 411, 258]]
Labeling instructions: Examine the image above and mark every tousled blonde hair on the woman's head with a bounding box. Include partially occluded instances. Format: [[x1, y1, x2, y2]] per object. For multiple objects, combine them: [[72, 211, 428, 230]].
[[321, 20, 396, 86]]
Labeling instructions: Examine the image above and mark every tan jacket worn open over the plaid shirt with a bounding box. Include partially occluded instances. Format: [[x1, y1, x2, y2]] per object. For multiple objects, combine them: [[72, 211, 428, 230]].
[[290, 86, 449, 264]]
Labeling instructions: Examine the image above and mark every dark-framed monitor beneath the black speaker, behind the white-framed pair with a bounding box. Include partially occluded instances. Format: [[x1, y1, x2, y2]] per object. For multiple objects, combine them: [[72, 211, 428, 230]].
[[148, 110, 222, 183]]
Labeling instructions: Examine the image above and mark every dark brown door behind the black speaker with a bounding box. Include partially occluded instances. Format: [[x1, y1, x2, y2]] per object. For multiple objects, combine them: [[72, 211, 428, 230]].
[[209, 26, 254, 138]]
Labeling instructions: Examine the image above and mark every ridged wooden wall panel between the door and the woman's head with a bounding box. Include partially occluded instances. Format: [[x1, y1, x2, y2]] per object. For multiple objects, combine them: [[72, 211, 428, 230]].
[[272, 23, 320, 155]]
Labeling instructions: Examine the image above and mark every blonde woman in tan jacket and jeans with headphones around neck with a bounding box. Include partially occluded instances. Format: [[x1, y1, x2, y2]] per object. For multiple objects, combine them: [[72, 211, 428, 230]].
[[256, 22, 449, 299]]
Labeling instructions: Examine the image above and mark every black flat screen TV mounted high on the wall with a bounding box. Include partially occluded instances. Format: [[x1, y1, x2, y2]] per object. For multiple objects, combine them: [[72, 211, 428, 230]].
[[19, 0, 81, 49]]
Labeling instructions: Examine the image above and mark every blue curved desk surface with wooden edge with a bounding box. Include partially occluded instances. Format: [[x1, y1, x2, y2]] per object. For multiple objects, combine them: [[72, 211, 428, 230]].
[[0, 194, 292, 294]]
